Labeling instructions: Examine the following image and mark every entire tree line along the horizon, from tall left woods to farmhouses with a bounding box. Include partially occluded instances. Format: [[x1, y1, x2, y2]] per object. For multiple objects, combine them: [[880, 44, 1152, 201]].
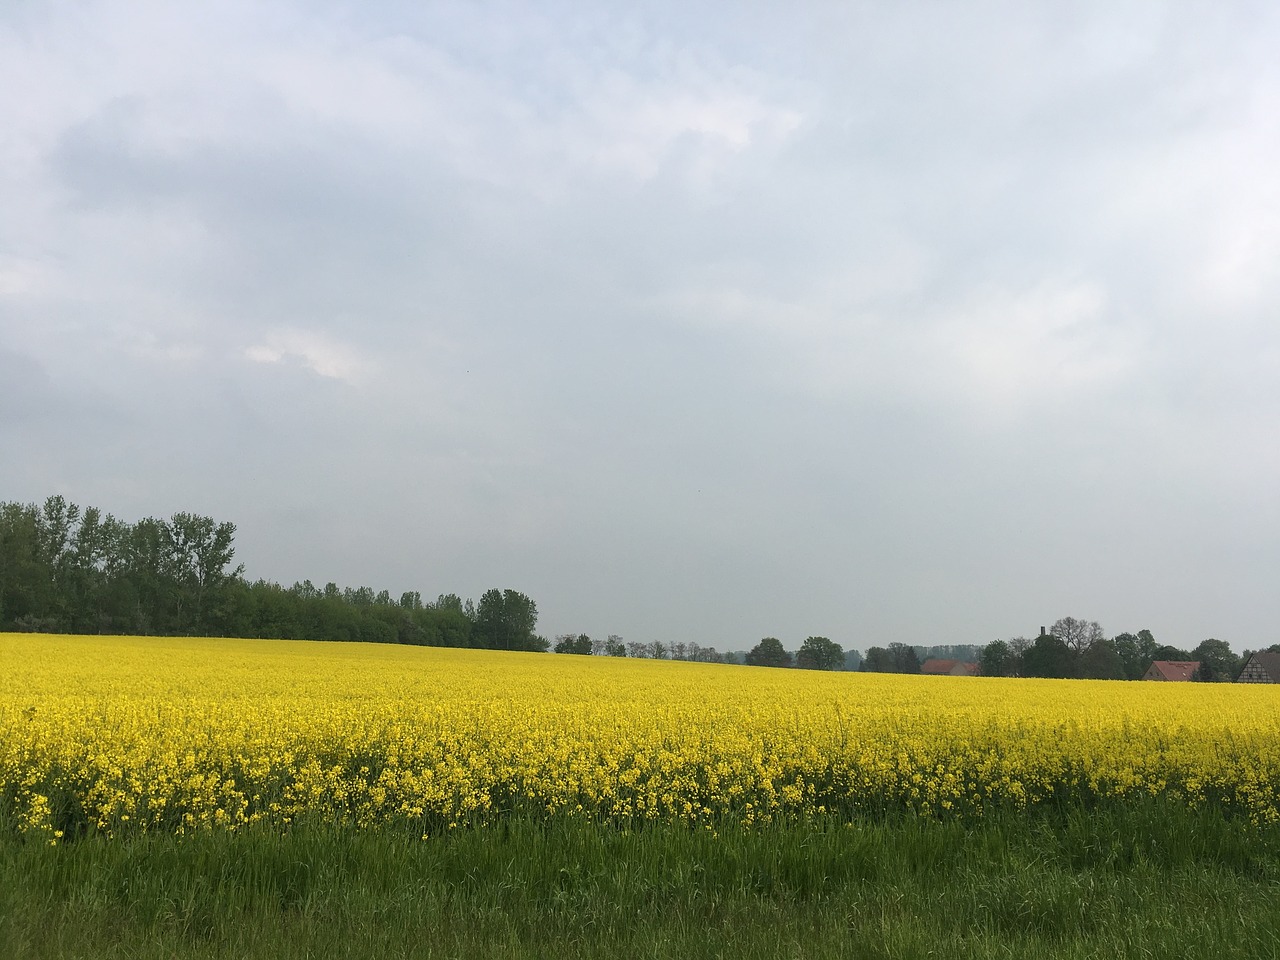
[[0, 495, 1259, 681]]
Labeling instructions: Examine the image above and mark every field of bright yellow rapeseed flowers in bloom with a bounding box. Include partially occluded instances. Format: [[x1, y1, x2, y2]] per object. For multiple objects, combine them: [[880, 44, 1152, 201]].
[[0, 635, 1280, 841]]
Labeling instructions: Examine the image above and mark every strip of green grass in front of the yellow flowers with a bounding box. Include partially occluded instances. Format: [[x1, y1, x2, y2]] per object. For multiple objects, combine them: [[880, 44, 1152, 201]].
[[0, 806, 1280, 960]]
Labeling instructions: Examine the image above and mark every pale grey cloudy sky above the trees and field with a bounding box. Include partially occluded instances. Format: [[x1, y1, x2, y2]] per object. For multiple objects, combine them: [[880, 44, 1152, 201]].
[[0, 0, 1280, 650]]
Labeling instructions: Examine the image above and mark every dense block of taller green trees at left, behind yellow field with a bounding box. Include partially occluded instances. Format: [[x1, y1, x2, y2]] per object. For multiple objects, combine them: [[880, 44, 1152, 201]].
[[0, 495, 549, 650]]
